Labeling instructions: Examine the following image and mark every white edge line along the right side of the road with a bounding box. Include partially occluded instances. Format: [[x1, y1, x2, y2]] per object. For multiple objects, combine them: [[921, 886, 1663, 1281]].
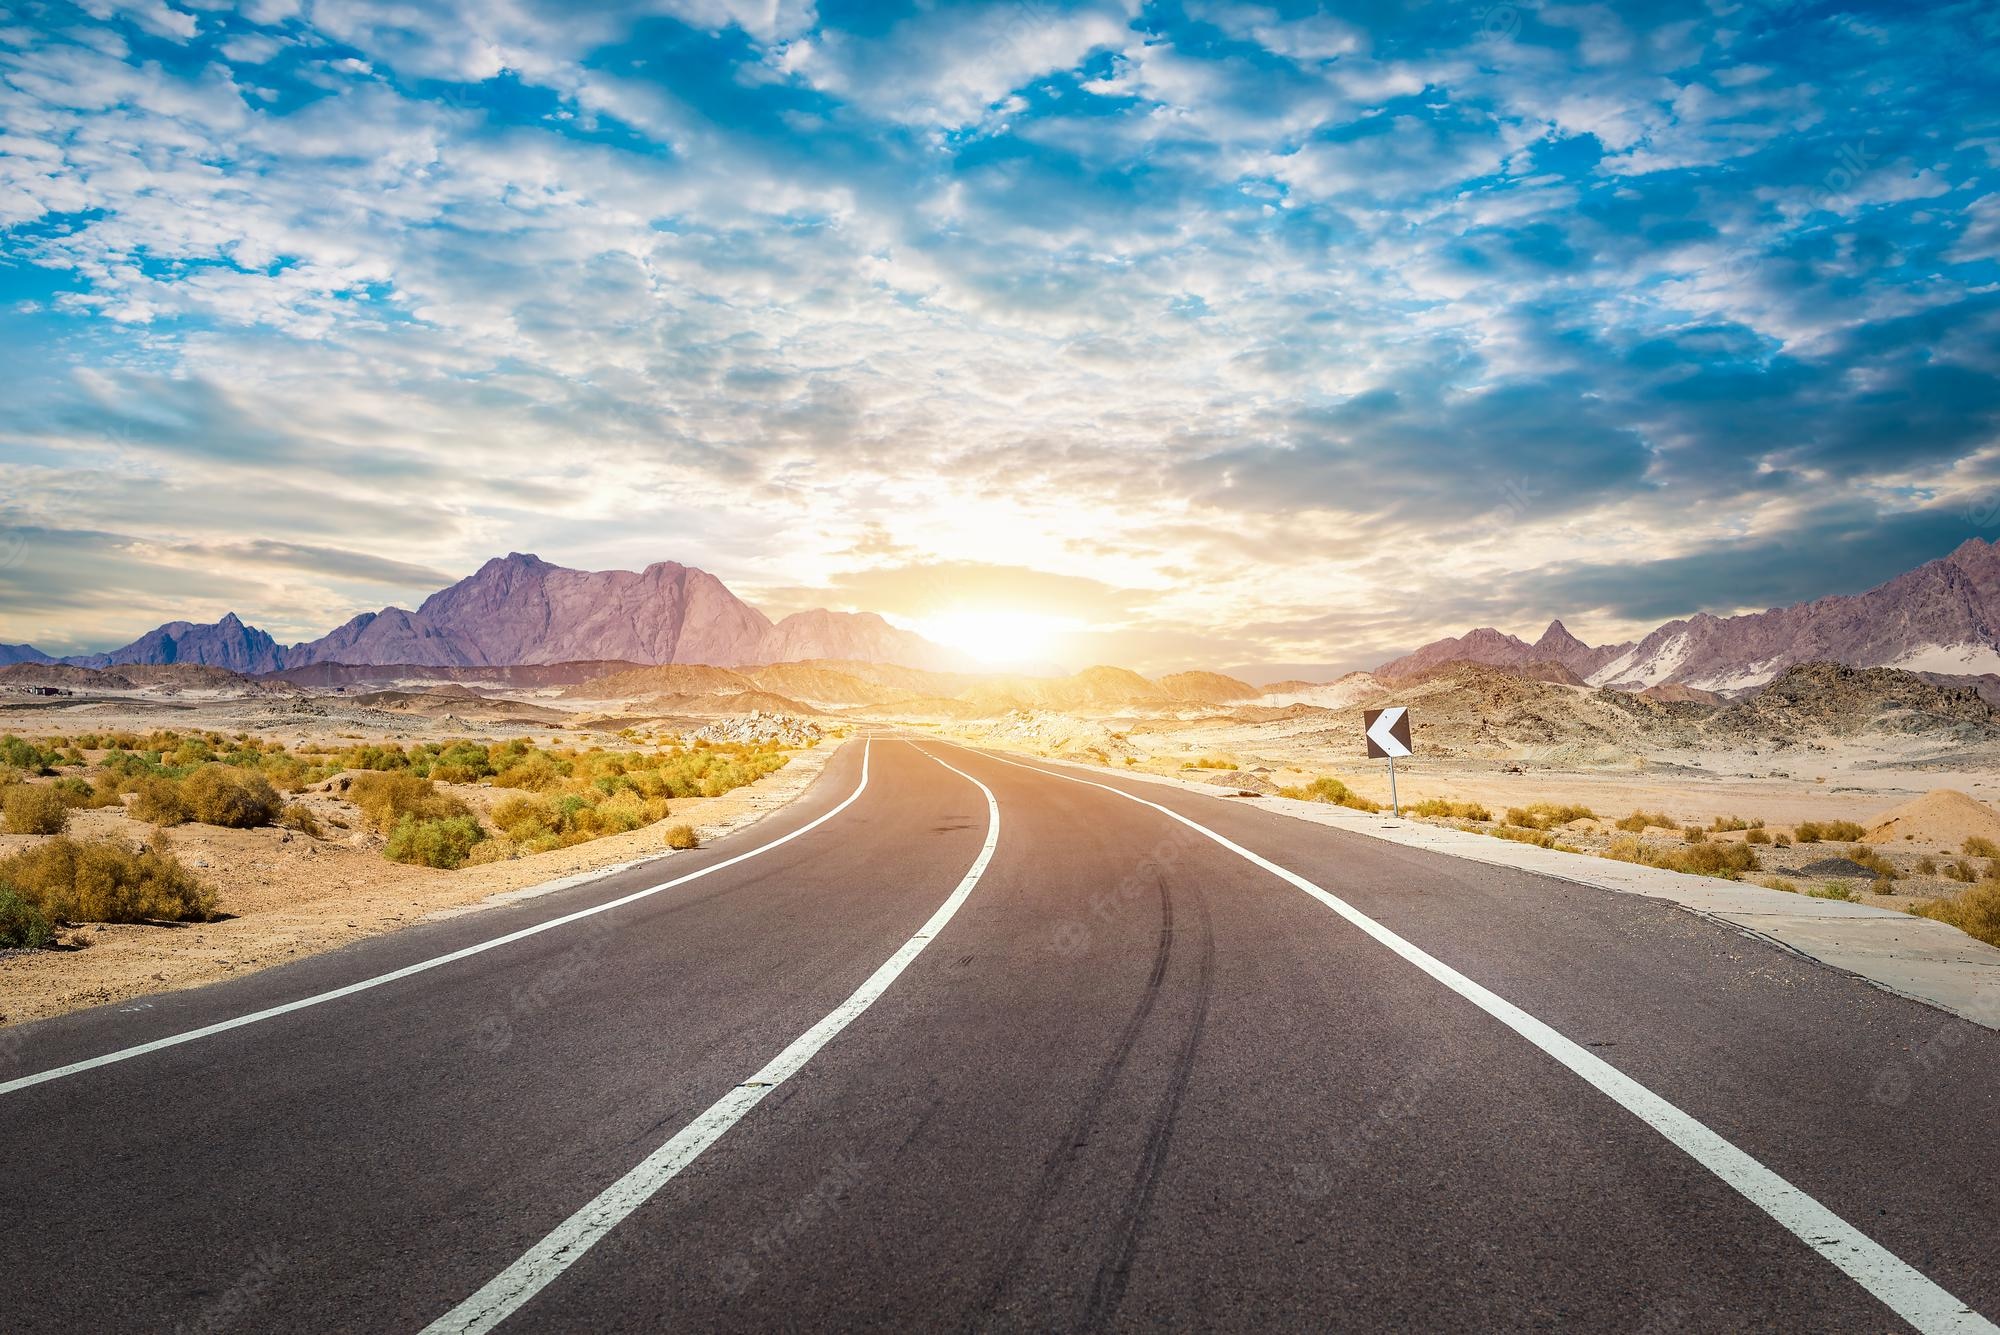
[[946, 743, 2000, 1335]]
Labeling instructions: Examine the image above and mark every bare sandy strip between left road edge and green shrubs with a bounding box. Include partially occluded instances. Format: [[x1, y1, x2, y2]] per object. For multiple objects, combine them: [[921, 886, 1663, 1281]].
[[0, 747, 838, 1025]]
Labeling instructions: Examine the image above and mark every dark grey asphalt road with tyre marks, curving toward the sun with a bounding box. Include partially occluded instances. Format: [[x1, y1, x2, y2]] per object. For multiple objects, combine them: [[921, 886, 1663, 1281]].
[[0, 735, 2000, 1333]]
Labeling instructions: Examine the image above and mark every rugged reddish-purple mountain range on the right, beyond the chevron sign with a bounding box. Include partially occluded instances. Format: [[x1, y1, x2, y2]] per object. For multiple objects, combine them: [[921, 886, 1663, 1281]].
[[1376, 538, 2000, 695]]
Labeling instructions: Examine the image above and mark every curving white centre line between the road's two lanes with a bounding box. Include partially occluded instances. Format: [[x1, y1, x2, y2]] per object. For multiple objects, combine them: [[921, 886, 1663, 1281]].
[[424, 745, 1000, 1335]]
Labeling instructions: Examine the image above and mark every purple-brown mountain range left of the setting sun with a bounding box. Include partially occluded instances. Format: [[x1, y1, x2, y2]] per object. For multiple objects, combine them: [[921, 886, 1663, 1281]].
[[27, 552, 964, 675]]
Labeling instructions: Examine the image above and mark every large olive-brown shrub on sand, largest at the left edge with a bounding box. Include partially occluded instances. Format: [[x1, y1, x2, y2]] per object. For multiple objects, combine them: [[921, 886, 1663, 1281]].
[[0, 835, 216, 923]]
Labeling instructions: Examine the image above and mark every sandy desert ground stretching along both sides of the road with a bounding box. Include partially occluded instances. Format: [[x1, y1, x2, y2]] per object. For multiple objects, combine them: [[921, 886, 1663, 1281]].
[[0, 662, 2000, 1023]]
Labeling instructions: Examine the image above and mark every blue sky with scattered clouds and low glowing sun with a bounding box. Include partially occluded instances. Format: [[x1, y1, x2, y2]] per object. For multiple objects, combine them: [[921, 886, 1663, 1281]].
[[0, 0, 2000, 677]]
